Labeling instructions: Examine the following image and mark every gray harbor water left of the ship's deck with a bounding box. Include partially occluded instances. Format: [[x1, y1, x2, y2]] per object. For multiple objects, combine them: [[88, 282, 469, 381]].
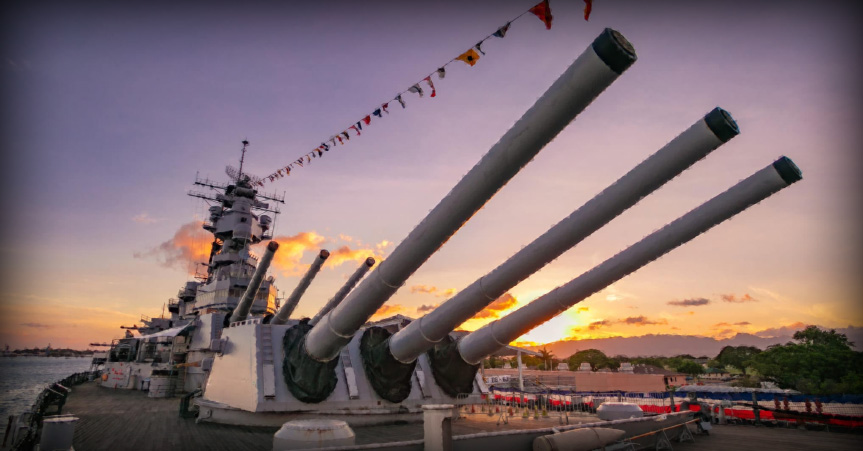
[[0, 357, 92, 441]]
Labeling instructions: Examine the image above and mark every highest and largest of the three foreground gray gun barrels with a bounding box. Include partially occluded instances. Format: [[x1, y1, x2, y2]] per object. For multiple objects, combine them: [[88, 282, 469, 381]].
[[304, 28, 636, 362]]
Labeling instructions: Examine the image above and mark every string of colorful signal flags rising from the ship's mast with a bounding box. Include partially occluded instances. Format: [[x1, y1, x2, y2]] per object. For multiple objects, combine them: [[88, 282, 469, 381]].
[[257, 0, 593, 186]]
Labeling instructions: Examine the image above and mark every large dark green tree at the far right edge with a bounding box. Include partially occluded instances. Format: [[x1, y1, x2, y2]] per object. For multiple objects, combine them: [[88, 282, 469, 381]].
[[752, 326, 863, 395]]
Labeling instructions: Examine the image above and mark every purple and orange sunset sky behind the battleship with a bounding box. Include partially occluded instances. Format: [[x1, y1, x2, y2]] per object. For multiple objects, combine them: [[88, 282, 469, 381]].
[[0, 0, 863, 349]]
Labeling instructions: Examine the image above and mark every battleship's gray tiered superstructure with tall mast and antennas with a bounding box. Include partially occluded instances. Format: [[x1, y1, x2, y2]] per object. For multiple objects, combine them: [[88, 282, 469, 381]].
[[103, 141, 284, 391]]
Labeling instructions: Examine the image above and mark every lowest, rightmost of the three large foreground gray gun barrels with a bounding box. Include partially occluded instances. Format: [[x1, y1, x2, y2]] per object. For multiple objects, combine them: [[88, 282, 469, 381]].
[[458, 157, 802, 365]]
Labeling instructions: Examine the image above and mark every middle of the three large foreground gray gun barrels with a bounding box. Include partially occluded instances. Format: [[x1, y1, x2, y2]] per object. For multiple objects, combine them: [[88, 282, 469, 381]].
[[389, 107, 739, 363]]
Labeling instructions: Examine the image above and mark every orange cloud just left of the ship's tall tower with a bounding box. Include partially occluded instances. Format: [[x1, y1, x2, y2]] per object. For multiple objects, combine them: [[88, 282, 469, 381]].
[[132, 221, 211, 274]]
